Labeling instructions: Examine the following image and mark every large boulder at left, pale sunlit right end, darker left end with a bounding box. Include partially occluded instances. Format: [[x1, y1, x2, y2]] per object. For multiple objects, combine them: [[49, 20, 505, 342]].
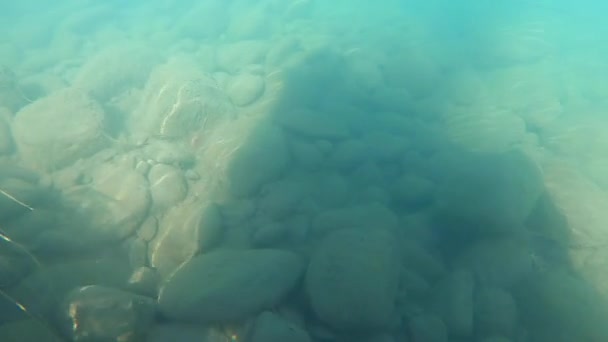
[[11, 158, 150, 255]]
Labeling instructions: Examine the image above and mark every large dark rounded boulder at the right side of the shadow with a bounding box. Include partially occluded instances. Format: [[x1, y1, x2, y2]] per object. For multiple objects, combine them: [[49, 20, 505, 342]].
[[436, 150, 545, 238]]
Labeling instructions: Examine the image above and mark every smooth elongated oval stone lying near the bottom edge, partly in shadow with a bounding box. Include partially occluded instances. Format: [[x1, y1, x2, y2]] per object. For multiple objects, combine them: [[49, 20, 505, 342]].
[[158, 249, 304, 323]]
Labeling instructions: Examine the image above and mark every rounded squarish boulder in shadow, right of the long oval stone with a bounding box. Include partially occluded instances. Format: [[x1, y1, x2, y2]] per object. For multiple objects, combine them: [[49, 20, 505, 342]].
[[306, 227, 399, 332]]
